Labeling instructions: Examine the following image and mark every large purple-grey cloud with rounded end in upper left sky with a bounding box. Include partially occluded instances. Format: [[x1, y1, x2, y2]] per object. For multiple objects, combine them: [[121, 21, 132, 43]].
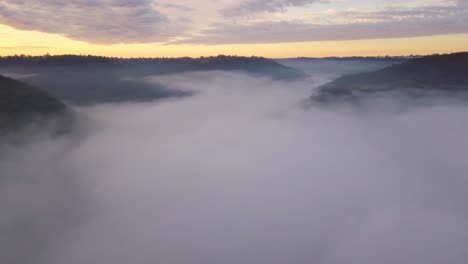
[[0, 0, 186, 43]]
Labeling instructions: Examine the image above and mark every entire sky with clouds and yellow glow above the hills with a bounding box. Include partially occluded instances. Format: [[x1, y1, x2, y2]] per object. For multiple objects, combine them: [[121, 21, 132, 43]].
[[0, 0, 468, 58]]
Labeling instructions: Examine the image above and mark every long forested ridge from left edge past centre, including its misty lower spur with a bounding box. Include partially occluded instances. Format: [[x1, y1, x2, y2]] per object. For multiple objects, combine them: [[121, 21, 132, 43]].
[[0, 55, 305, 105]]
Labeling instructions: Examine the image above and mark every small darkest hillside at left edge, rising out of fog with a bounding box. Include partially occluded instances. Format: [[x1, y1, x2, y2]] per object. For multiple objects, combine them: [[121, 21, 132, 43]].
[[0, 76, 70, 134]]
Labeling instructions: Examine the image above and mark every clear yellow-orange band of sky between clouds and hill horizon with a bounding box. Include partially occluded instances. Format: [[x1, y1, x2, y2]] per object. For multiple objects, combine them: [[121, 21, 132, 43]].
[[0, 25, 468, 58]]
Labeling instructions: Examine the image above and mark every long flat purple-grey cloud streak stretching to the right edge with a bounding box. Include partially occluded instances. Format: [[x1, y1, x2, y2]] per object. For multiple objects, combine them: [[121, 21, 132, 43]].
[[181, 3, 468, 44]]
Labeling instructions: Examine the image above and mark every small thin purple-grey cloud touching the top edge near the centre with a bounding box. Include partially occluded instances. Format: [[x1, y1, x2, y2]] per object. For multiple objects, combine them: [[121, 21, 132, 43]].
[[221, 0, 329, 17]]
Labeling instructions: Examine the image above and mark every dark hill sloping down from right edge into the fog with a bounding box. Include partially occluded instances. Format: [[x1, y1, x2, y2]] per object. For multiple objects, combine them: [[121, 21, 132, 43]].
[[312, 52, 468, 102]]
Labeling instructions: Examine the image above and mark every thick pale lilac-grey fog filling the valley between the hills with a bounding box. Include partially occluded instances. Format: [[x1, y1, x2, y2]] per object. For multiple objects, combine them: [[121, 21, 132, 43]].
[[0, 65, 468, 264]]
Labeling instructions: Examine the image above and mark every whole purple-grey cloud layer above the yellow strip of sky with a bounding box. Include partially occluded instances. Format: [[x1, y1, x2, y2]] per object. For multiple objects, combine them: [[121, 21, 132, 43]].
[[0, 0, 468, 44]]
